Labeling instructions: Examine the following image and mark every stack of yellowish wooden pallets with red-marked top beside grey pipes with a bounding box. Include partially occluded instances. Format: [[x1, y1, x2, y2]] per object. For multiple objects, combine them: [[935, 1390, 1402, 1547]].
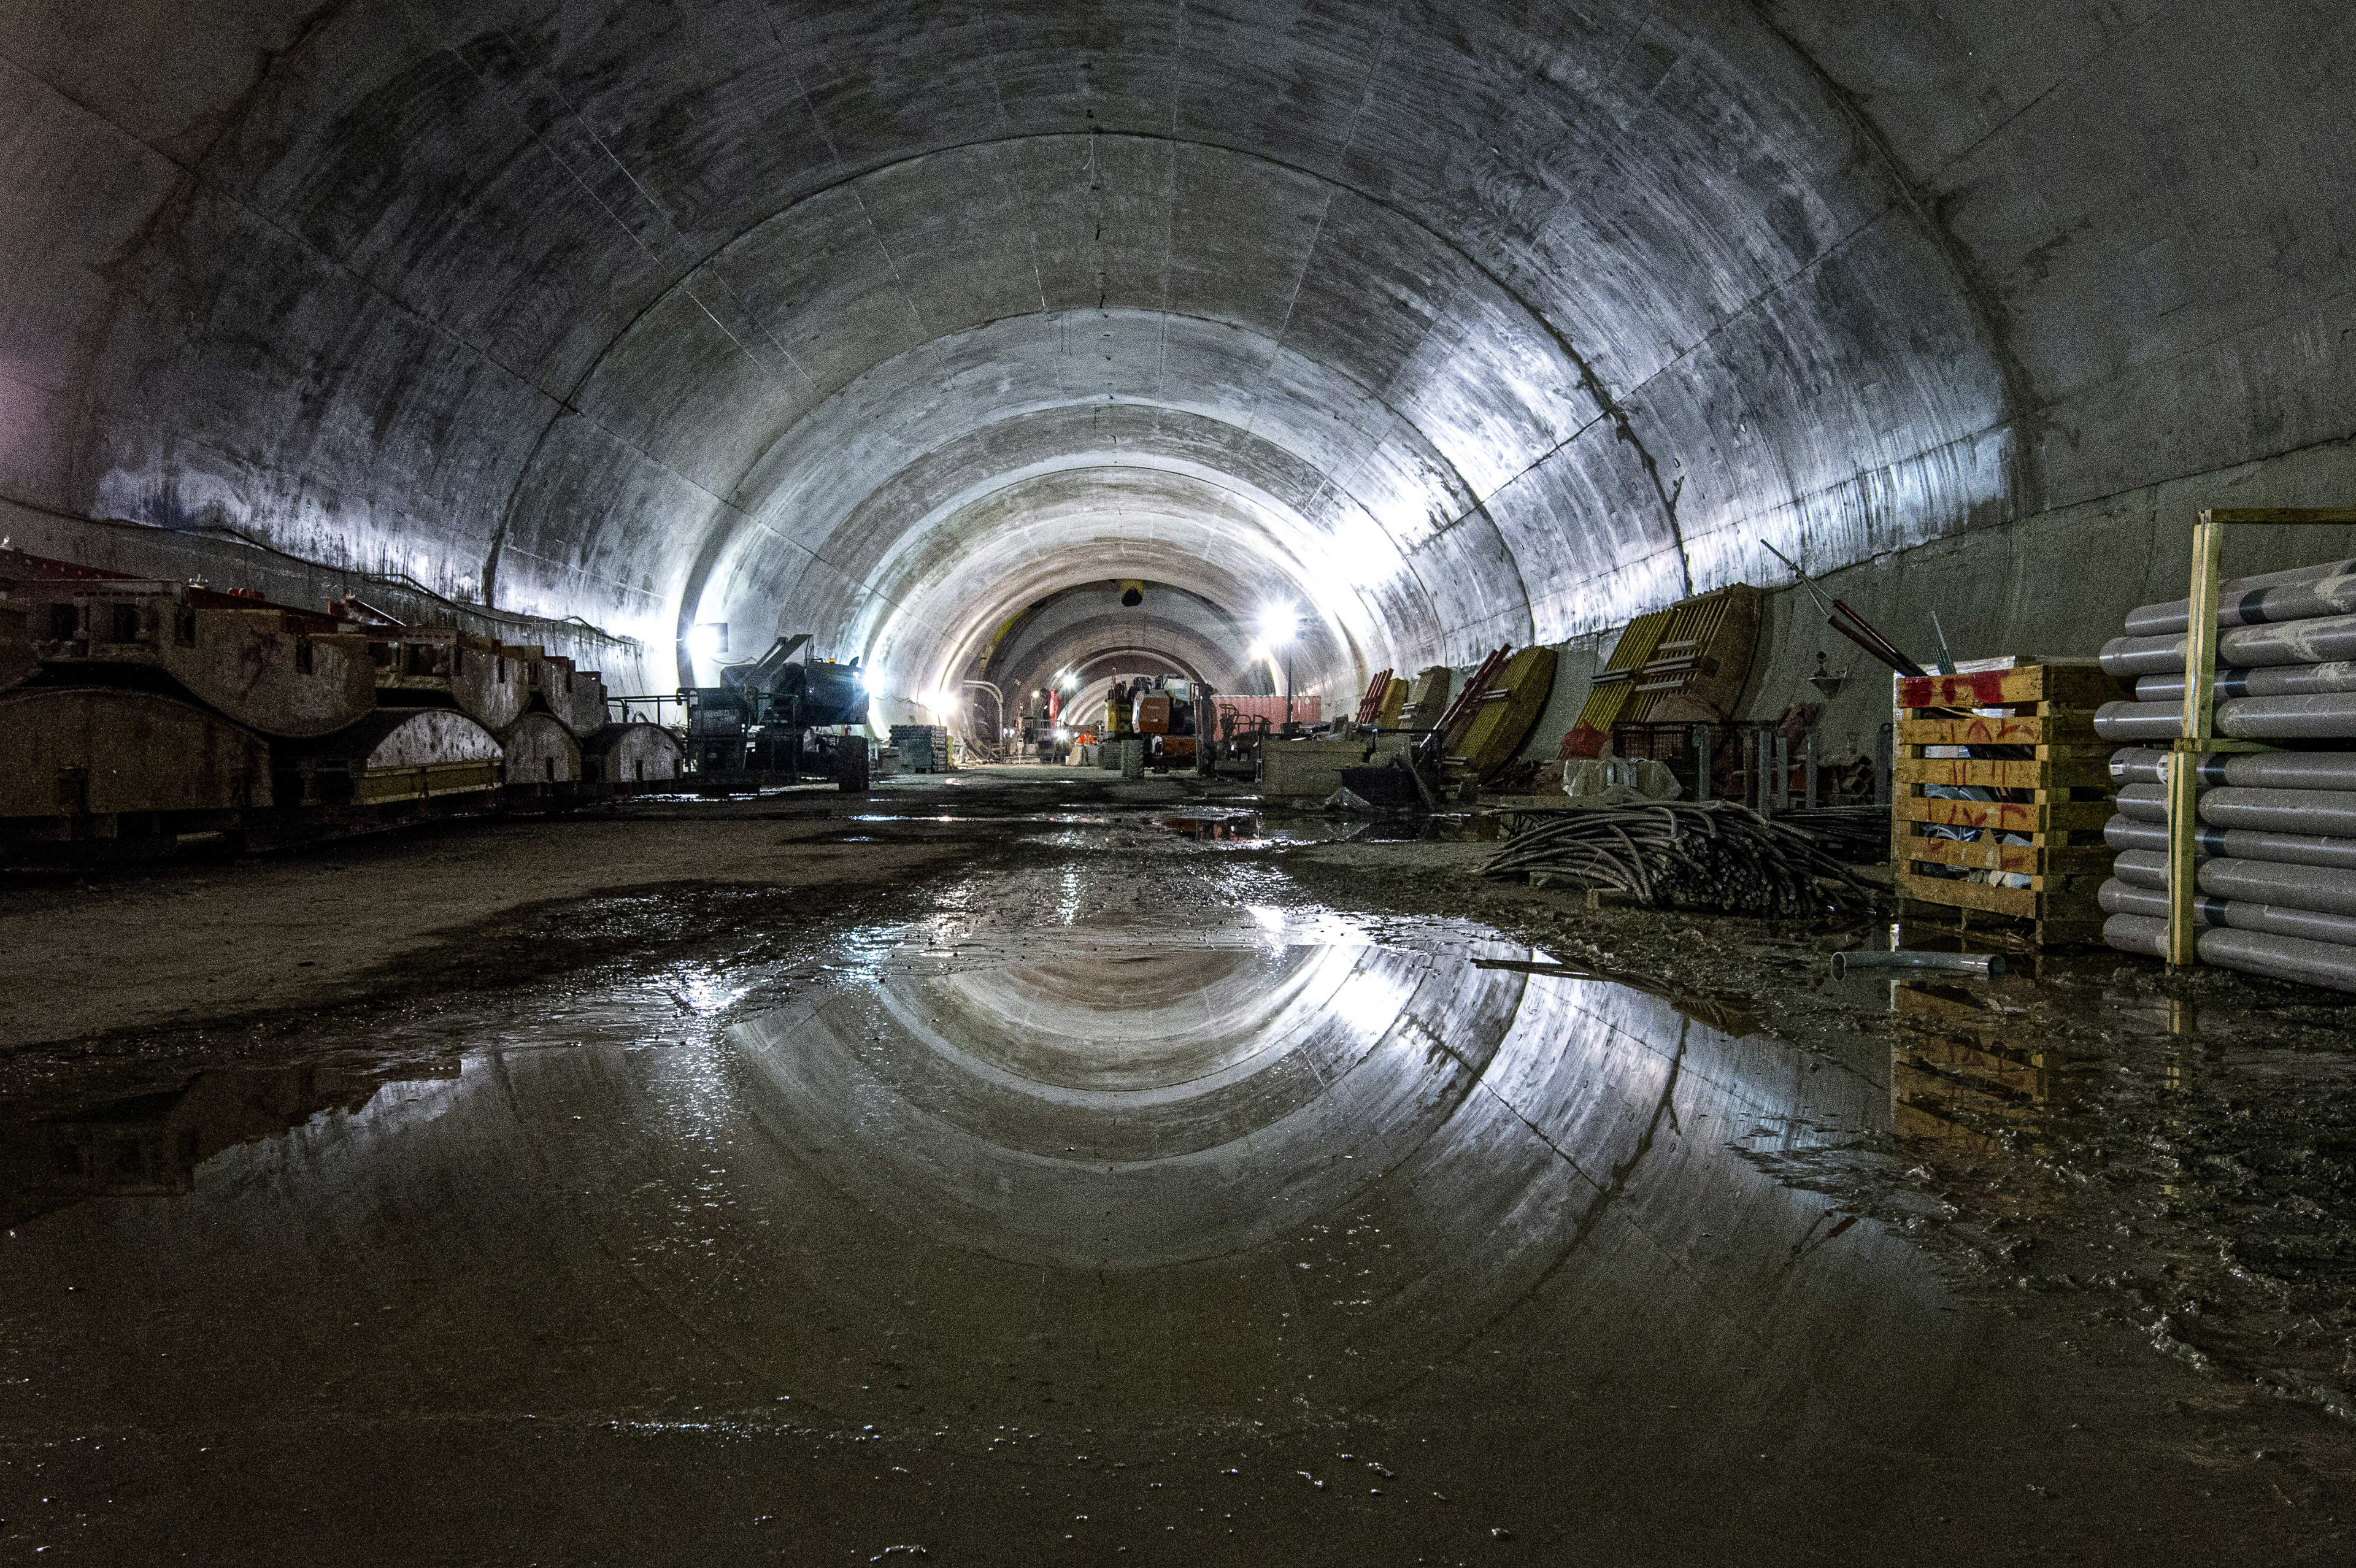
[[1890, 664, 2128, 947]]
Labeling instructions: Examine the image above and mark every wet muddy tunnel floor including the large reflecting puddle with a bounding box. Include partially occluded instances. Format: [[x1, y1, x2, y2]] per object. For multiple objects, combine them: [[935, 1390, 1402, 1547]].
[[0, 770, 2356, 1563]]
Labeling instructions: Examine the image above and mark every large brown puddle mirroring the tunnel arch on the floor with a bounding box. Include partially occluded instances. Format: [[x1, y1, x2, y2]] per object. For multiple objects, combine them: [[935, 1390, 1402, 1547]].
[[0, 862, 2281, 1561]]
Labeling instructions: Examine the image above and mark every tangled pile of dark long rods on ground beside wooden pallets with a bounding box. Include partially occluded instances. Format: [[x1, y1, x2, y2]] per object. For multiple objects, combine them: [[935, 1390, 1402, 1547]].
[[1482, 801, 1876, 916]]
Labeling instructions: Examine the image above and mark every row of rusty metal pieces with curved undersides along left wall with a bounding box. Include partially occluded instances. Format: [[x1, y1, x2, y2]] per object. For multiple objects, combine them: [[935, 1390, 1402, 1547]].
[[0, 548, 683, 859]]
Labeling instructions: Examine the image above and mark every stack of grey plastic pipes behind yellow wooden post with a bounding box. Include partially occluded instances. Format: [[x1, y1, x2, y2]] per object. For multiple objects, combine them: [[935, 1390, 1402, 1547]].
[[2095, 560, 2356, 991]]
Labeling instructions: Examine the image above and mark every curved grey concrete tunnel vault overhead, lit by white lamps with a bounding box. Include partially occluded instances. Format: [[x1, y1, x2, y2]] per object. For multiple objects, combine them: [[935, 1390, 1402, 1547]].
[[0, 0, 2349, 697]]
